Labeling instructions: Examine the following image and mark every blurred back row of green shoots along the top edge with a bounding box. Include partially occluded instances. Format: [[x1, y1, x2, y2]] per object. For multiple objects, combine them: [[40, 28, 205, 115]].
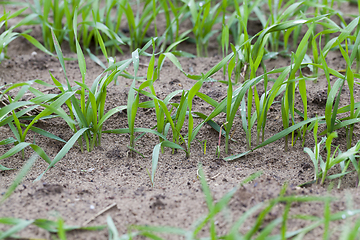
[[0, 0, 346, 58]]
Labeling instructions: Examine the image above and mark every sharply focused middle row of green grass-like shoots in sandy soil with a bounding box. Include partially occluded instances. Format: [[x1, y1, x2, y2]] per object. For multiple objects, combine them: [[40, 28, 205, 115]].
[[0, 1, 360, 183]]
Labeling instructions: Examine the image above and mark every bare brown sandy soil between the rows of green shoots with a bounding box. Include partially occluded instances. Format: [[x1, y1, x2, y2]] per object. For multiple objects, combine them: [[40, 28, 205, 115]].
[[0, 2, 360, 239]]
